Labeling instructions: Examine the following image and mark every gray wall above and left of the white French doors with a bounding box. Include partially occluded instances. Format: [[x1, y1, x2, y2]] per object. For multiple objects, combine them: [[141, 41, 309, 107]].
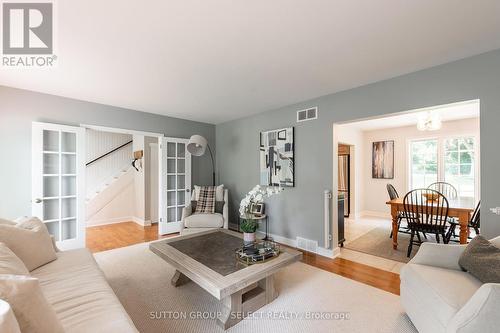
[[0, 86, 215, 218]]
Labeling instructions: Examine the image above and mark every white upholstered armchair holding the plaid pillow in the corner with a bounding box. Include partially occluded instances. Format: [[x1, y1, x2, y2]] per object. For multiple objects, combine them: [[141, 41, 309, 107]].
[[181, 187, 229, 235]]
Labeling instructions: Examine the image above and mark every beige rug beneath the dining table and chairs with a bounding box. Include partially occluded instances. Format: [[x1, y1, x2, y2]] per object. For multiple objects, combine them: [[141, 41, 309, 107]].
[[344, 227, 435, 263]]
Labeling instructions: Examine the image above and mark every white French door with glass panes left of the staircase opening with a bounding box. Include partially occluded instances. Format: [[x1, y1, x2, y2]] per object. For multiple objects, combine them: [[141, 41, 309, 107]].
[[32, 122, 85, 250]]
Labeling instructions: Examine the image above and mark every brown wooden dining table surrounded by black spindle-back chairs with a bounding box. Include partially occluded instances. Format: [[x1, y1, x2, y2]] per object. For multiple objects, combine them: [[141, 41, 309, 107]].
[[386, 197, 475, 250]]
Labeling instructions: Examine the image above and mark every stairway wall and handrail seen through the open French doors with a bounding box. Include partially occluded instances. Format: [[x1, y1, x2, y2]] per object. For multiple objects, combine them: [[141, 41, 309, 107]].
[[85, 127, 160, 227]]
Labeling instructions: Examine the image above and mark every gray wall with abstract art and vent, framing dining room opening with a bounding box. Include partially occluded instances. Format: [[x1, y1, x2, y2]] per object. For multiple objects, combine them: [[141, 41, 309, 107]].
[[216, 50, 500, 244]]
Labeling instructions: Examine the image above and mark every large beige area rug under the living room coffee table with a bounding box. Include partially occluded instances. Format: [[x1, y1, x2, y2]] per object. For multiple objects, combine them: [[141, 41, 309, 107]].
[[95, 244, 416, 333]]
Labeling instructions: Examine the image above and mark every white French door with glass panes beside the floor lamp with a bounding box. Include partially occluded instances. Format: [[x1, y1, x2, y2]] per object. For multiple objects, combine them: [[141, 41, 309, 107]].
[[158, 138, 191, 235]]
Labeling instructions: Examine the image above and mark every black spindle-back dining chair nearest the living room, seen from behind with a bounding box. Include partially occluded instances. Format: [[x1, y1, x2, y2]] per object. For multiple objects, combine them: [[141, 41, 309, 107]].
[[403, 188, 449, 257]]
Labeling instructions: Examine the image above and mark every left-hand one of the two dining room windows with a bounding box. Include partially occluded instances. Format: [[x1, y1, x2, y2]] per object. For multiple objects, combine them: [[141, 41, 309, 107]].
[[410, 139, 438, 189]]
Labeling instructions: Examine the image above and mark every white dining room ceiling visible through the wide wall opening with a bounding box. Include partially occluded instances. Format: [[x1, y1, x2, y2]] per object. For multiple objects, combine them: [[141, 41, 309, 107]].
[[341, 101, 480, 131]]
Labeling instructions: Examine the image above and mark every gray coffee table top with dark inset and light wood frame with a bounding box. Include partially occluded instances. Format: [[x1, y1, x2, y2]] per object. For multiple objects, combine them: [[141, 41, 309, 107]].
[[149, 229, 302, 300]]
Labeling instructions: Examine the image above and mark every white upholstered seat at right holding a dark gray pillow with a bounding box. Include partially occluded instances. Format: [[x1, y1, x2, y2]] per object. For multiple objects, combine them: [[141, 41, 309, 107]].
[[401, 237, 500, 333]]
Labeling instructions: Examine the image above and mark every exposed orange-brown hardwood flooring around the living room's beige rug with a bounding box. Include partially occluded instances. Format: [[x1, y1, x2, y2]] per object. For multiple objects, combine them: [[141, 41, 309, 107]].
[[87, 222, 400, 295]]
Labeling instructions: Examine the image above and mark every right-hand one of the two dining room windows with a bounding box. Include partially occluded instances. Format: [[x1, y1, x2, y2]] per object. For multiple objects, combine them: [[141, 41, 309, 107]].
[[444, 137, 475, 198]]
